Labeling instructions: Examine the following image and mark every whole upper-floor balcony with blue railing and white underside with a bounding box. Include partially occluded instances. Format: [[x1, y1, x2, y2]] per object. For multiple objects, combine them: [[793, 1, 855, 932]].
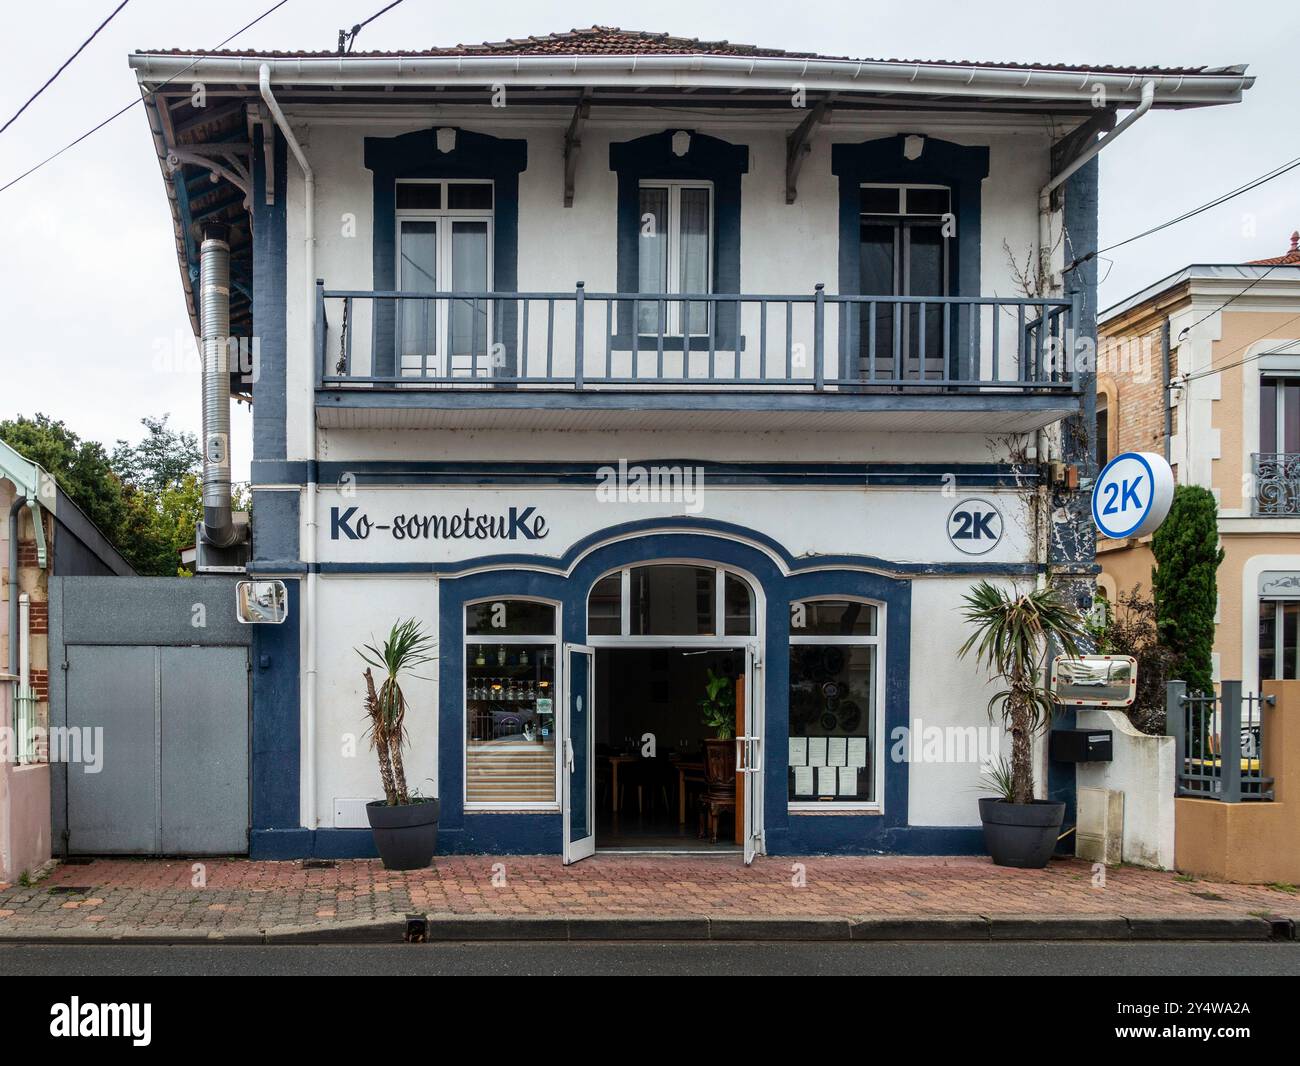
[[315, 282, 1080, 433]]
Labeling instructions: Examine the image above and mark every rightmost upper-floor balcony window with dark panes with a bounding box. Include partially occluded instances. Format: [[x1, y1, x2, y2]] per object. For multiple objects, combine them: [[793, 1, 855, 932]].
[[858, 185, 956, 378]]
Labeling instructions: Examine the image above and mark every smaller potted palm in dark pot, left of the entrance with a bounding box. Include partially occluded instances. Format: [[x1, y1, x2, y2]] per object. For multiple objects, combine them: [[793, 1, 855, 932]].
[[356, 619, 438, 870]]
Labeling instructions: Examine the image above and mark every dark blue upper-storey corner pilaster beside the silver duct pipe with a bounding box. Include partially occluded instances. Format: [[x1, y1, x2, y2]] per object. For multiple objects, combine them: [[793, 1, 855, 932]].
[[252, 122, 289, 462]]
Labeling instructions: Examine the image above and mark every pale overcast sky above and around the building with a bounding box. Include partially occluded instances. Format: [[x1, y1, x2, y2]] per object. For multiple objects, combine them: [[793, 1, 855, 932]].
[[0, 0, 1300, 477]]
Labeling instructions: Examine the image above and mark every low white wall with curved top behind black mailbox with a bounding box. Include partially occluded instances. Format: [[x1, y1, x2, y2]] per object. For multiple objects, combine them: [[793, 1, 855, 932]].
[[1075, 707, 1175, 870]]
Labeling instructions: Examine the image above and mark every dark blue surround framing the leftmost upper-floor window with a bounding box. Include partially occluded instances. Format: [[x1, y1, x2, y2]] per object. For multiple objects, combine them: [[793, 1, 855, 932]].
[[365, 126, 528, 376]]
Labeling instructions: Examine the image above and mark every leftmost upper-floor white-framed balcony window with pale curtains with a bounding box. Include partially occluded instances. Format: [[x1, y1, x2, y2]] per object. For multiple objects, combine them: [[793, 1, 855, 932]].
[[394, 179, 493, 376]]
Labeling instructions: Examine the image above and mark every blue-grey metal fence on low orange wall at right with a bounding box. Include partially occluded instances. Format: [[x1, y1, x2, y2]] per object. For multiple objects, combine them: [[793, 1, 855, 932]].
[[1165, 681, 1274, 803]]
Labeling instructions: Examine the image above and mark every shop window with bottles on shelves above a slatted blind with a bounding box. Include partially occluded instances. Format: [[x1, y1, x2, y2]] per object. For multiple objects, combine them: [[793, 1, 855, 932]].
[[465, 599, 559, 809]]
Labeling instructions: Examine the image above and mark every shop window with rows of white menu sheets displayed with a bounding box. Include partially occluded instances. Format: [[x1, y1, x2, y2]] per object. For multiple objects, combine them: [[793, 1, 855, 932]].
[[788, 599, 881, 807]]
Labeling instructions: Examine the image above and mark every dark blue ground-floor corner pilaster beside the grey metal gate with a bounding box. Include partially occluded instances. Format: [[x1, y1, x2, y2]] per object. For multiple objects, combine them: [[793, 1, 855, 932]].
[[248, 580, 303, 837]]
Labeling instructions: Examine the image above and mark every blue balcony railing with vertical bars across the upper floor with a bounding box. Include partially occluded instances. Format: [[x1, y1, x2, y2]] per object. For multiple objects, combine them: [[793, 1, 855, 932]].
[[315, 282, 1080, 393]]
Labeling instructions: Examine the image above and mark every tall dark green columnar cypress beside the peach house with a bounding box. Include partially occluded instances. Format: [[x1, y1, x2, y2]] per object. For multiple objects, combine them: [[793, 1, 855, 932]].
[[1152, 485, 1223, 693]]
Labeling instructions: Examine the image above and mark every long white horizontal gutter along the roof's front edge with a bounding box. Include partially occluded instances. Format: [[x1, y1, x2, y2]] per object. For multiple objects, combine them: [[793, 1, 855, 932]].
[[130, 53, 1255, 107]]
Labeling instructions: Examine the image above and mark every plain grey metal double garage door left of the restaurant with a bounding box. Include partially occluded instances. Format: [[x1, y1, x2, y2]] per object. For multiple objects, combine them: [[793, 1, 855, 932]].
[[66, 645, 248, 855]]
